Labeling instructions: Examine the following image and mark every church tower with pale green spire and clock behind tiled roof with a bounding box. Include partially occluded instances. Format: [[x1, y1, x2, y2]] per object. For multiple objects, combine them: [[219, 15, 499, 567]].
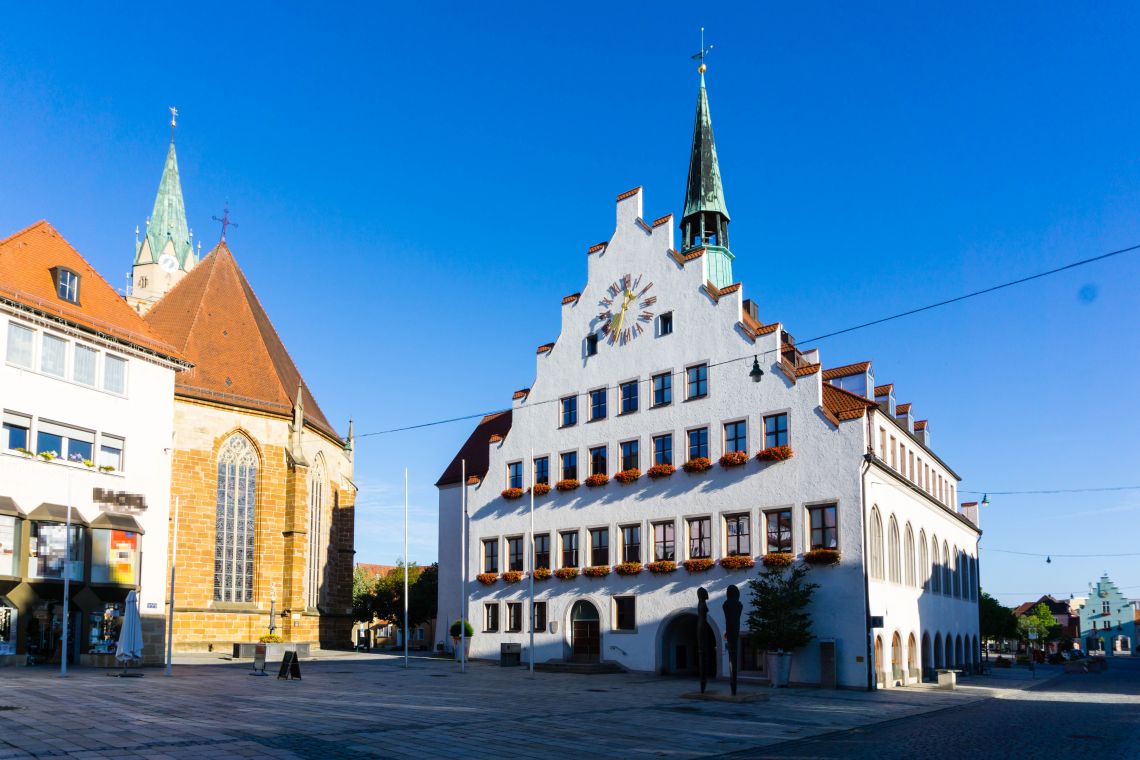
[[127, 108, 198, 313]]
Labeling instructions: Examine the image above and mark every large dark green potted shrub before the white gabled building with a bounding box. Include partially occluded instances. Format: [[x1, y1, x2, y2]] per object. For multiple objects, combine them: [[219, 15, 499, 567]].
[[748, 565, 819, 686]]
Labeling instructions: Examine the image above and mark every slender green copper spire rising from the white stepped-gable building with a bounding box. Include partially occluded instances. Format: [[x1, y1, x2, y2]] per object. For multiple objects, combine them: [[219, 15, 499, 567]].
[[681, 63, 734, 287]]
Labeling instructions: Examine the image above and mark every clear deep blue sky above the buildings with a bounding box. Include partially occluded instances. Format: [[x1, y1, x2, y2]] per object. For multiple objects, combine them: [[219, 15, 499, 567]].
[[0, 2, 1140, 603]]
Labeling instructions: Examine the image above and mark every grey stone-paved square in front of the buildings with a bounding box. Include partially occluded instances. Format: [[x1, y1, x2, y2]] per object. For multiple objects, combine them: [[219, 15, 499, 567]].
[[0, 654, 1067, 760]]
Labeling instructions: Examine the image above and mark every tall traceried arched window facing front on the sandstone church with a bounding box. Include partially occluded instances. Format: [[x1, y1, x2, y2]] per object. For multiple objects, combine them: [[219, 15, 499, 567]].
[[214, 433, 258, 602]]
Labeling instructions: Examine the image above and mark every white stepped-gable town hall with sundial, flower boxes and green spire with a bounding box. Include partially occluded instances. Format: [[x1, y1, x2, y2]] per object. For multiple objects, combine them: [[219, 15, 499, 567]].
[[437, 67, 980, 688]]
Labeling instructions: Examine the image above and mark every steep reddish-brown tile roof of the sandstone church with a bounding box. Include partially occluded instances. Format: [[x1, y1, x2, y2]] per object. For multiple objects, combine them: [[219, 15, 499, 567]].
[[145, 243, 340, 440]]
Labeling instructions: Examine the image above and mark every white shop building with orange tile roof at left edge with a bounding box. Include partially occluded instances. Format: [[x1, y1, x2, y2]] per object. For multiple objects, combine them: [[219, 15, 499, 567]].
[[0, 221, 188, 664]]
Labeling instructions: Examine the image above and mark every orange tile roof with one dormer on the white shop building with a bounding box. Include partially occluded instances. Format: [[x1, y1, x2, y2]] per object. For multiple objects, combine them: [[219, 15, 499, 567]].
[[0, 221, 186, 363]]
